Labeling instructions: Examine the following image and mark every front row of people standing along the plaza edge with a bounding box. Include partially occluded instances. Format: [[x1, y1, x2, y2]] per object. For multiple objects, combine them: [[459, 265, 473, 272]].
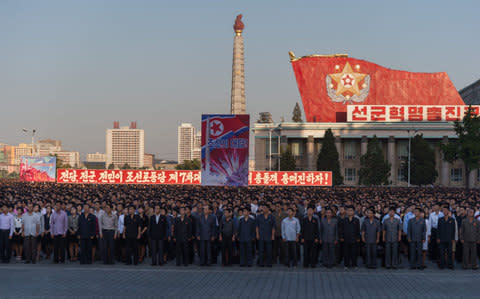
[[0, 202, 480, 269]]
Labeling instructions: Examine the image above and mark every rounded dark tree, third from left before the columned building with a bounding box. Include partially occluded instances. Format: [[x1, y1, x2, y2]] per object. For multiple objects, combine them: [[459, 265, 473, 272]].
[[403, 134, 438, 186]]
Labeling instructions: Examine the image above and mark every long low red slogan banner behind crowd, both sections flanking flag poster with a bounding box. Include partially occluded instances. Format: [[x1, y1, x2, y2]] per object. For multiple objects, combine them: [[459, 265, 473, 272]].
[[57, 169, 332, 186]]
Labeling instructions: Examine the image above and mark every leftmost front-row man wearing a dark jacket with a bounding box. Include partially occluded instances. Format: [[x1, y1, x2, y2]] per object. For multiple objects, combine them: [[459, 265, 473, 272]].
[[77, 204, 97, 264]]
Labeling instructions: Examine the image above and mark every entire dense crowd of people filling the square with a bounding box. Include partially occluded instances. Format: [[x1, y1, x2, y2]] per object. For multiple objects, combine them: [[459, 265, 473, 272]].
[[0, 180, 480, 270]]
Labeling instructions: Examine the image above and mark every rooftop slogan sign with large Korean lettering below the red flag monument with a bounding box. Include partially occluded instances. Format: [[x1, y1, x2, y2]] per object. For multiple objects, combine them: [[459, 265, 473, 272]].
[[347, 105, 480, 122]]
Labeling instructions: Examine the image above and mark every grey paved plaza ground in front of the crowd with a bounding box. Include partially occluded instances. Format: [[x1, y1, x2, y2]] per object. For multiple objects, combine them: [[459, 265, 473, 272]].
[[0, 262, 480, 299]]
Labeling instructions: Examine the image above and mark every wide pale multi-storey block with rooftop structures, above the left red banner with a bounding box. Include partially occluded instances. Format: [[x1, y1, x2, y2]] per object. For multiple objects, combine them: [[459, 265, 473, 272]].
[[106, 121, 145, 168]]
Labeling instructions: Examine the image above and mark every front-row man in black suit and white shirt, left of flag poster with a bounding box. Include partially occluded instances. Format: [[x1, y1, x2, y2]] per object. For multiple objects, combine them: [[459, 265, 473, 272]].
[[148, 204, 168, 266]]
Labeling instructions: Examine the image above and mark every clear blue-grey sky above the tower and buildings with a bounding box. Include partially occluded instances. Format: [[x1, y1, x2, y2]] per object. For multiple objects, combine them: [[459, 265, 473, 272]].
[[0, 0, 480, 159]]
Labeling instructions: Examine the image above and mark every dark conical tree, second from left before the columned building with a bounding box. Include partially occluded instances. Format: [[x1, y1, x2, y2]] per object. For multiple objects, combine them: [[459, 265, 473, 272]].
[[358, 135, 392, 186]]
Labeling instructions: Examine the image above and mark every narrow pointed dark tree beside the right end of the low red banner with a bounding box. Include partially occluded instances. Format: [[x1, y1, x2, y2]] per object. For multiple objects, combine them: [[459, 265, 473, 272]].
[[317, 129, 343, 186]]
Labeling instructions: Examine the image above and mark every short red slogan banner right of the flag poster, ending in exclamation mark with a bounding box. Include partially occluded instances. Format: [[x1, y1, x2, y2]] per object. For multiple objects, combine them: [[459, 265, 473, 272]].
[[248, 171, 332, 186]]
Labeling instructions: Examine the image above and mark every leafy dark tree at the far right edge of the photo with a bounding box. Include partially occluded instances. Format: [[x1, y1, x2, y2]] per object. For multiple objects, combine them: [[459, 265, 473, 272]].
[[440, 106, 480, 189]]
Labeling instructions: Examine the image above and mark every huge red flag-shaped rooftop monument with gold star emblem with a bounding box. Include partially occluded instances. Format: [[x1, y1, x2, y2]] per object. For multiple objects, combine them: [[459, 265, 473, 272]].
[[292, 55, 465, 122]]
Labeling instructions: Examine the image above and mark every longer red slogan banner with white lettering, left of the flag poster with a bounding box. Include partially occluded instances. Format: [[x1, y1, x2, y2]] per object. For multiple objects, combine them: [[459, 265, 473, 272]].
[[57, 169, 200, 185]]
